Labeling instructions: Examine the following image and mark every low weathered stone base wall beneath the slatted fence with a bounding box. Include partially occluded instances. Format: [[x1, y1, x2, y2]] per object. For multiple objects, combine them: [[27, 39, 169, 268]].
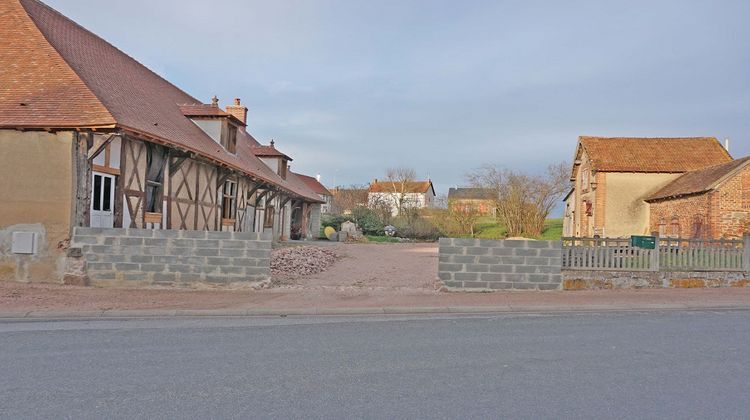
[[563, 270, 750, 290]]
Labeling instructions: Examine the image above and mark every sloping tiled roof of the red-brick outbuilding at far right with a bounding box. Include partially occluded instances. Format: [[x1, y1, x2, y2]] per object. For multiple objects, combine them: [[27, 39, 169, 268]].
[[646, 157, 750, 201]]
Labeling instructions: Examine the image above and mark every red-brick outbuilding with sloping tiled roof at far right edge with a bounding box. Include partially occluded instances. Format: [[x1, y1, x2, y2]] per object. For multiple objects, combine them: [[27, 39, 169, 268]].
[[646, 157, 750, 238]]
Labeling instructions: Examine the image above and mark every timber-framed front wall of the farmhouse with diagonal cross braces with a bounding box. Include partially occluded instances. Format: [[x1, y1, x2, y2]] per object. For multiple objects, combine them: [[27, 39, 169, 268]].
[[71, 132, 310, 239]]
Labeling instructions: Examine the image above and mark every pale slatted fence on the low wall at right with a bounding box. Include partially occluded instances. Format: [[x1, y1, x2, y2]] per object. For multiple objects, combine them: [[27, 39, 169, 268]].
[[562, 237, 750, 271]]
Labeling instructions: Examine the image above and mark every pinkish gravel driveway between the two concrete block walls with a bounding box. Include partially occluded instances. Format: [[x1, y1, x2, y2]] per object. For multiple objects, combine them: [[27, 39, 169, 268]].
[[273, 242, 438, 291]]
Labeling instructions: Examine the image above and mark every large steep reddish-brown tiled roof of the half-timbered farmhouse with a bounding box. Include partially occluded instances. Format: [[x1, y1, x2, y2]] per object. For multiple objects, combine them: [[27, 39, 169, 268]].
[[0, 0, 319, 201]]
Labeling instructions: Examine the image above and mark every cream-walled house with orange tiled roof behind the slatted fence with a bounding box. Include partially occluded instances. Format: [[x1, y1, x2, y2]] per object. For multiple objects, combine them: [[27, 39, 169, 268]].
[[563, 136, 732, 237]]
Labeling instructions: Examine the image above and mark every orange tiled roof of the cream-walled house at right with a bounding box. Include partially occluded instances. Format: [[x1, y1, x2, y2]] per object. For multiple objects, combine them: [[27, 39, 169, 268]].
[[576, 136, 732, 173]]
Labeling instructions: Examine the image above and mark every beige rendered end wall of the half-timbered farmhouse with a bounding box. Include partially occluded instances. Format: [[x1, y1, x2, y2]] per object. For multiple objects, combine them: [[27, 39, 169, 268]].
[[0, 130, 73, 282]]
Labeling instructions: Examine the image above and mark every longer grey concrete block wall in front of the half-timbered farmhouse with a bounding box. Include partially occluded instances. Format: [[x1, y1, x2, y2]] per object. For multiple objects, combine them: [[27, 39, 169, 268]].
[[69, 227, 271, 285]]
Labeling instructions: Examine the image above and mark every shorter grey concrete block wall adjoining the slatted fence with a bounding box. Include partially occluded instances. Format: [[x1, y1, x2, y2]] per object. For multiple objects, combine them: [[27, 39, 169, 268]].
[[438, 238, 562, 290]]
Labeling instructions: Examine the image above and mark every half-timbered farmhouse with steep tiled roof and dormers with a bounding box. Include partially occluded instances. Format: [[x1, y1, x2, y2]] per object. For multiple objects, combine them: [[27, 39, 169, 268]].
[[0, 0, 323, 279]]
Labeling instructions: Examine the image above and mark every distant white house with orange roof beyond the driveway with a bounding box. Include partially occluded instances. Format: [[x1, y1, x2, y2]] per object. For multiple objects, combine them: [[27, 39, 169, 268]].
[[367, 179, 435, 216]]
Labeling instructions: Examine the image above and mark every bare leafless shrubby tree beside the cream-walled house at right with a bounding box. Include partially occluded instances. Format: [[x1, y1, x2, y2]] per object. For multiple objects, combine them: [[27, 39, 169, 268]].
[[467, 163, 569, 237]]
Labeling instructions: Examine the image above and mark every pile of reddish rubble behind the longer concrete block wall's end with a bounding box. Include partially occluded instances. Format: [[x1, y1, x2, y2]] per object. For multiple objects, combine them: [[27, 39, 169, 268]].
[[271, 246, 336, 276]]
